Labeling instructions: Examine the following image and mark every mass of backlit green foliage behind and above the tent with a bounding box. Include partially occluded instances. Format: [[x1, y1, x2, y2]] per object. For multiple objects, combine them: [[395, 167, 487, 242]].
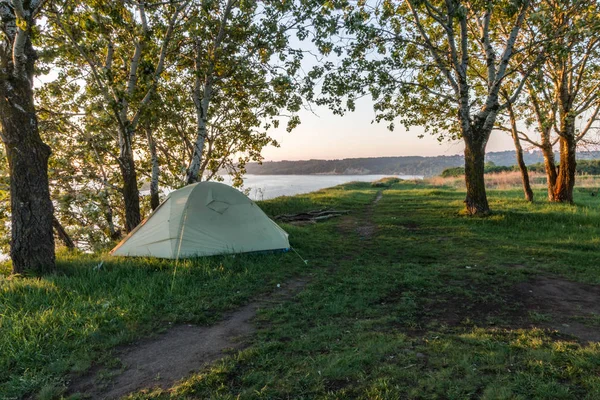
[[30, 1, 302, 250]]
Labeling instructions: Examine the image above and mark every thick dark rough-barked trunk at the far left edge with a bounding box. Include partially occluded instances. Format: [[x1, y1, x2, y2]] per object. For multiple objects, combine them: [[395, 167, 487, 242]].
[[0, 78, 55, 273]]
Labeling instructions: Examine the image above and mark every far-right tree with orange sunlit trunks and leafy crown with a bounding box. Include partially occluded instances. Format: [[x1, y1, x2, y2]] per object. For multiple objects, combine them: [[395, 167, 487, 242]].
[[496, 0, 600, 202]]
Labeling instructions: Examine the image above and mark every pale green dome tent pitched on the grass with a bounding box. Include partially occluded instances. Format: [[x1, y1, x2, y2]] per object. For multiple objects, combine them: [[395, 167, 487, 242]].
[[111, 182, 290, 259]]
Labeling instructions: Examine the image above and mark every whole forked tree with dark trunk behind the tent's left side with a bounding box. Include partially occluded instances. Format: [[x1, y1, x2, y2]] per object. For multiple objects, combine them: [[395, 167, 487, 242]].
[[49, 0, 189, 232]]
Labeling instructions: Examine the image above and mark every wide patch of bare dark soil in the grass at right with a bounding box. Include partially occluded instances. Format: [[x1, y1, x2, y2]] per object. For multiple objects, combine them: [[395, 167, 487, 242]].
[[379, 277, 600, 343]]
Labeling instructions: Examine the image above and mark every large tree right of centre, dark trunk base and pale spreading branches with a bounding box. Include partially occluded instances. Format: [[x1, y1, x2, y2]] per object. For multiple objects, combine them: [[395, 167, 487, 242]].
[[315, 0, 531, 215]]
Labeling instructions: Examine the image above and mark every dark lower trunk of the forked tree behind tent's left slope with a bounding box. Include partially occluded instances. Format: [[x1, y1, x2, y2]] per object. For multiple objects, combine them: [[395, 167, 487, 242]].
[[119, 132, 142, 233]]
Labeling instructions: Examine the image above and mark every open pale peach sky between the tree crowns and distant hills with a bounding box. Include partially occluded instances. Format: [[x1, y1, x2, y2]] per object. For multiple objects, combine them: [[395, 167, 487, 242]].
[[263, 99, 514, 161]]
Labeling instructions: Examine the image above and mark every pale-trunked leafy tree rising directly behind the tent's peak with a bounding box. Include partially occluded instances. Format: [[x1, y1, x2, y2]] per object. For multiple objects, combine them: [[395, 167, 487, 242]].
[[186, 0, 302, 184]]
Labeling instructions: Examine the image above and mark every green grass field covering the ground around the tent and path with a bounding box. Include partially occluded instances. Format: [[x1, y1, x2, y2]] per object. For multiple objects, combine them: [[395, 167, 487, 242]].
[[0, 182, 600, 399]]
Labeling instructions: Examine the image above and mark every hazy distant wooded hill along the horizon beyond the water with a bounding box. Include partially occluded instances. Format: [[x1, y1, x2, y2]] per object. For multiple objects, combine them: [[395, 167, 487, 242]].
[[246, 151, 600, 176]]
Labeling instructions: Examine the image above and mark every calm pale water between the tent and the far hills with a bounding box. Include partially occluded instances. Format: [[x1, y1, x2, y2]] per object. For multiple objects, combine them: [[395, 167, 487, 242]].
[[225, 175, 423, 200]]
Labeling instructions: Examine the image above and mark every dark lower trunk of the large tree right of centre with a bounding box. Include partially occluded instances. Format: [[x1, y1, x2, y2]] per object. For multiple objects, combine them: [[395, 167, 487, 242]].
[[465, 138, 490, 215]]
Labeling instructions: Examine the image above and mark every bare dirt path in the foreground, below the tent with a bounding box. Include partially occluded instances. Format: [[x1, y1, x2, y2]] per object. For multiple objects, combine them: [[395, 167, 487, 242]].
[[69, 278, 308, 399]]
